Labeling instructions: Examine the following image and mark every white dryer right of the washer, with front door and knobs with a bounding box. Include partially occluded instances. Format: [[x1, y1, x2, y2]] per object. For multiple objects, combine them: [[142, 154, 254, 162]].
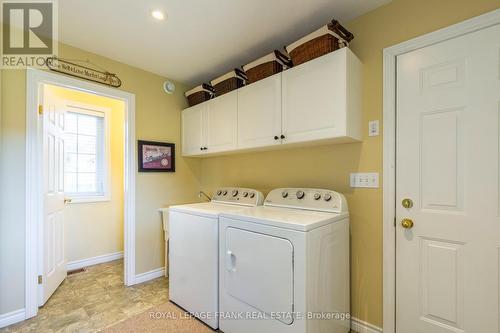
[[219, 188, 350, 333]]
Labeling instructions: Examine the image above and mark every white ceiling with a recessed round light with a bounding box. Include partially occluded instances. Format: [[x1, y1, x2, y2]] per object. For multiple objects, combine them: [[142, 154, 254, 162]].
[[59, 0, 390, 85]]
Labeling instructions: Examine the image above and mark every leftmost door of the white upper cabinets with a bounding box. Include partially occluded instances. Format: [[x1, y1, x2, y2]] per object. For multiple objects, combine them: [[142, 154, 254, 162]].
[[182, 102, 207, 156]]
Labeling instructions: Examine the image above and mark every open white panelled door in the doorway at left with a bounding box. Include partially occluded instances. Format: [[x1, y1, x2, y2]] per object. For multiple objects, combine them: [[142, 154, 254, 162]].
[[39, 85, 66, 305]]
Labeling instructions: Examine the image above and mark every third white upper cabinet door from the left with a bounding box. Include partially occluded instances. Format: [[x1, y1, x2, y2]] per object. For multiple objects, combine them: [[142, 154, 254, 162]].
[[238, 74, 281, 148]]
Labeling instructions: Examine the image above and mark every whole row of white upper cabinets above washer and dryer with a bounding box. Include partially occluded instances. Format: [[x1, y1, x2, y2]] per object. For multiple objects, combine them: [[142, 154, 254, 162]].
[[182, 48, 362, 156]]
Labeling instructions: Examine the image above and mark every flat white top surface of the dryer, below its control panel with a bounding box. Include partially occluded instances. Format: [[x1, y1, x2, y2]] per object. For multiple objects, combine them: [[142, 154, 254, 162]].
[[220, 206, 349, 231]]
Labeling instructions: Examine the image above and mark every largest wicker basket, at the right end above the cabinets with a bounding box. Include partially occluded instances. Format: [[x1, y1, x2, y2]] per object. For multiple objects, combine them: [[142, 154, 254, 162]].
[[286, 20, 354, 66]]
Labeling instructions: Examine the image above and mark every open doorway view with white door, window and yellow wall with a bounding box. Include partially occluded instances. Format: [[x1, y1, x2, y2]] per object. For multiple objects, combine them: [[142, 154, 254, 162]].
[[38, 84, 125, 306]]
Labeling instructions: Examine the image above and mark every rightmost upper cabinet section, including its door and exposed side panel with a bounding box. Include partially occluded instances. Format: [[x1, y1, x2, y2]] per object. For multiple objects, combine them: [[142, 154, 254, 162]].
[[282, 48, 361, 143]]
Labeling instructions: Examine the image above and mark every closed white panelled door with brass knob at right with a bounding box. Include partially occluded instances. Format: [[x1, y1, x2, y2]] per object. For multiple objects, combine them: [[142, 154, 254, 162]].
[[396, 26, 500, 333]]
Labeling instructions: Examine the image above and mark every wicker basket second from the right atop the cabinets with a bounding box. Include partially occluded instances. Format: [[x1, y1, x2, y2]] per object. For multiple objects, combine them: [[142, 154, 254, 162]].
[[243, 50, 292, 84]]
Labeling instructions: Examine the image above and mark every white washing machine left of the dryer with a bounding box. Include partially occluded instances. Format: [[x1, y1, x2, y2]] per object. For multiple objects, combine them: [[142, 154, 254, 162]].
[[169, 188, 264, 328]]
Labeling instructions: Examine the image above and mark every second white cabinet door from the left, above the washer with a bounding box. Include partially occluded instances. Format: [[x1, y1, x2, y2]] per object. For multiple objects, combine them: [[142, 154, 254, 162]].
[[205, 91, 238, 153]]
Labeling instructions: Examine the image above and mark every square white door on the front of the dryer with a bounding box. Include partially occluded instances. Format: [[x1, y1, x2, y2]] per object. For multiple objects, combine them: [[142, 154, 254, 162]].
[[225, 227, 293, 324]]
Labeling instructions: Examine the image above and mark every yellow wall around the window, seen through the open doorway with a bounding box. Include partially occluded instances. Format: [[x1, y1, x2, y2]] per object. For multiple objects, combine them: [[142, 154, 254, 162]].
[[48, 86, 125, 262]]
